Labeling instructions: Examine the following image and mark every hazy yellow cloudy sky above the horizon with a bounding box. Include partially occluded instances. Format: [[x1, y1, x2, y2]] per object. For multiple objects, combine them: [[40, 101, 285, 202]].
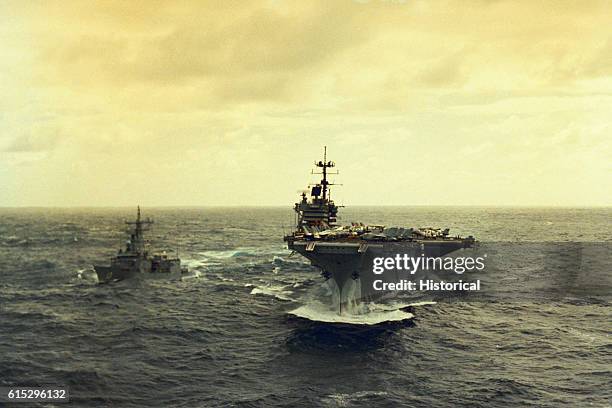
[[0, 0, 612, 206]]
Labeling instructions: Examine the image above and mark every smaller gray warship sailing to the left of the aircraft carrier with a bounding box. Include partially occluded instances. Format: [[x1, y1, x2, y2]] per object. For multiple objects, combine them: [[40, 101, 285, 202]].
[[94, 206, 189, 283]]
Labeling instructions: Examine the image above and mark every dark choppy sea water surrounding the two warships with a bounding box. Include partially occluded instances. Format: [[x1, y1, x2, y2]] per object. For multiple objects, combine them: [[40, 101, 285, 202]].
[[0, 208, 612, 407]]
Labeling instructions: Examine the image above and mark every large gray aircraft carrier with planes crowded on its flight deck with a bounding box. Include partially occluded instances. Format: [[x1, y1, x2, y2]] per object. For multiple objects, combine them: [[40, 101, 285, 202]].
[[284, 147, 477, 313]]
